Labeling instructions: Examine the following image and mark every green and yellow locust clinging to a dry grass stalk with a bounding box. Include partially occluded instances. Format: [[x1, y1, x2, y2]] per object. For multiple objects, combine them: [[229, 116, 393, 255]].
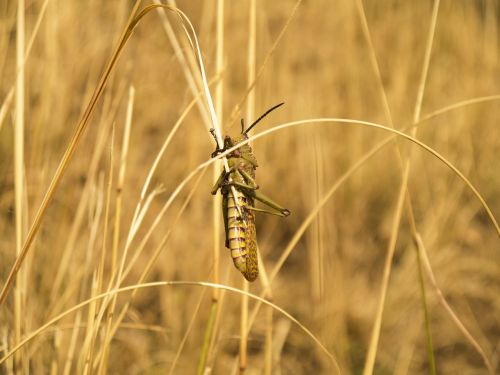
[[210, 103, 290, 281]]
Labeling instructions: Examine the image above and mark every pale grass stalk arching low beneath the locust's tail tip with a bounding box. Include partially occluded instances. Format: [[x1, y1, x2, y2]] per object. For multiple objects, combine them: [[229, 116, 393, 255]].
[[0, 281, 341, 374]]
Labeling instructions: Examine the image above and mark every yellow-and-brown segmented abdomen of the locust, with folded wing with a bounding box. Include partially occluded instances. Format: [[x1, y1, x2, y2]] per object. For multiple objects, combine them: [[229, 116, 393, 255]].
[[226, 189, 259, 281]]
